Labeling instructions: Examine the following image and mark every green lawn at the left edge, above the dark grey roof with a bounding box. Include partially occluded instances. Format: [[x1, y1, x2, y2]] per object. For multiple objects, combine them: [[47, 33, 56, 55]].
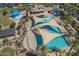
[[0, 15, 13, 27]]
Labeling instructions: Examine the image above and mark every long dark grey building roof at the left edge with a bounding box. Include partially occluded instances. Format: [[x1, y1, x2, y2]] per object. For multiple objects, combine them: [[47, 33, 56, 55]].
[[0, 28, 15, 37]]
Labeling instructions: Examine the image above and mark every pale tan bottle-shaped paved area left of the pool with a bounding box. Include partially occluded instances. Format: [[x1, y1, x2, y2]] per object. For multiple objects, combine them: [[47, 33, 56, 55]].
[[23, 19, 37, 51]]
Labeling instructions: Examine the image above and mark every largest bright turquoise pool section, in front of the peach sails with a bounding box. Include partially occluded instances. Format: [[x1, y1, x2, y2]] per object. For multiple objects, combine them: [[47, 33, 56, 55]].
[[46, 36, 69, 49]]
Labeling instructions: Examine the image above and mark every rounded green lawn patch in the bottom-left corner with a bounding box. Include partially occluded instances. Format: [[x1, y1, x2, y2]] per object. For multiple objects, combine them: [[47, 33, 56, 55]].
[[0, 47, 14, 56]]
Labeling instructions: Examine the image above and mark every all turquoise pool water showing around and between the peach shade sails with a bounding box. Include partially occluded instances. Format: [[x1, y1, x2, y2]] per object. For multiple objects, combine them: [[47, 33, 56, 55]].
[[36, 16, 69, 49]]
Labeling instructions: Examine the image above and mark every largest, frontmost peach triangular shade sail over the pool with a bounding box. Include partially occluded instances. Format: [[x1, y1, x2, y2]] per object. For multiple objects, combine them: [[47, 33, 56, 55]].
[[37, 28, 63, 45]]
